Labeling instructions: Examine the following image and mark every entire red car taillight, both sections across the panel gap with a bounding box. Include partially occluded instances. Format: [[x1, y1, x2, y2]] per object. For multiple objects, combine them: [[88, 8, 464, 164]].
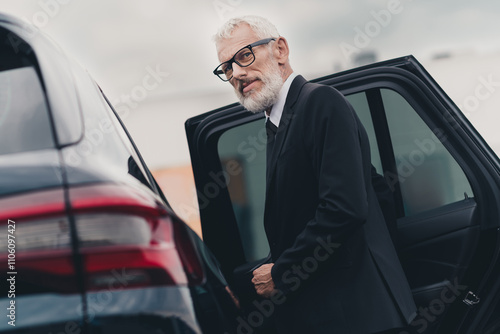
[[0, 185, 203, 293]]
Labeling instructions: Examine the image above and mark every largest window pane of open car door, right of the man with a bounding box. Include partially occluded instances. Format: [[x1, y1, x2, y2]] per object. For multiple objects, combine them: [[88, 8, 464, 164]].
[[380, 89, 473, 216]]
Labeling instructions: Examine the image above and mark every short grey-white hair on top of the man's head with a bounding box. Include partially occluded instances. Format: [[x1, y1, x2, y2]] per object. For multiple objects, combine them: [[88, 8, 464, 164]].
[[213, 15, 280, 45]]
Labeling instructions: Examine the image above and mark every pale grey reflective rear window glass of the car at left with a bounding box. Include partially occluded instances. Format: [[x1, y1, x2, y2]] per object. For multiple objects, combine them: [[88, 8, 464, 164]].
[[0, 66, 54, 155]]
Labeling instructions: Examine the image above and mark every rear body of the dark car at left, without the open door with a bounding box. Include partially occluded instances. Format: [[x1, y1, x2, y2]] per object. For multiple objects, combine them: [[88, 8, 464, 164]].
[[0, 15, 237, 334]]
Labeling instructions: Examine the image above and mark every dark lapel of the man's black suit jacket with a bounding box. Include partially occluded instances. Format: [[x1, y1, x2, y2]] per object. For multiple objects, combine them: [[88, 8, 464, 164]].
[[266, 75, 307, 188]]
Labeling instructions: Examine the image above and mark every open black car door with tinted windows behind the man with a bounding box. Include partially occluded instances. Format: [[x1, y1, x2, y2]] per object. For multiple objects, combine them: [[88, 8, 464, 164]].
[[186, 56, 500, 334]]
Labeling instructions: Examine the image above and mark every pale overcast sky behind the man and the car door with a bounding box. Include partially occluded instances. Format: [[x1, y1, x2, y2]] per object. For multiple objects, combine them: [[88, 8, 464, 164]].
[[0, 0, 500, 168]]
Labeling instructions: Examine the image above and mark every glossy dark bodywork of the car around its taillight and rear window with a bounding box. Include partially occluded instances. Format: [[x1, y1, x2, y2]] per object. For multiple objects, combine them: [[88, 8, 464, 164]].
[[0, 14, 236, 334]]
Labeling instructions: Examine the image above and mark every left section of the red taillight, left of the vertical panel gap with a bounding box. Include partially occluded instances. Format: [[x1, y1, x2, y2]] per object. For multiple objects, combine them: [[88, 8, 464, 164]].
[[0, 189, 78, 294]]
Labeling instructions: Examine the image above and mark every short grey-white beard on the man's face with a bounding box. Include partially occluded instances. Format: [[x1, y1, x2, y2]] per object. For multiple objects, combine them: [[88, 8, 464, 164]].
[[235, 66, 283, 113]]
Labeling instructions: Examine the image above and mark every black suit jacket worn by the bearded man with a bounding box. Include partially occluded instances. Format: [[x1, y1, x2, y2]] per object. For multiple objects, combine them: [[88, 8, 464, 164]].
[[264, 76, 416, 334]]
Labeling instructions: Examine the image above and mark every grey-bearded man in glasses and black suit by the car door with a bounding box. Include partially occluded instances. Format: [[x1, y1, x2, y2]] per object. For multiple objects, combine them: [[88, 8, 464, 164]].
[[214, 16, 416, 334]]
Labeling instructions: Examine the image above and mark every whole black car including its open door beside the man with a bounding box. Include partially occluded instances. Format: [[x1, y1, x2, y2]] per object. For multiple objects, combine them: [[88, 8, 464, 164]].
[[0, 10, 500, 334]]
